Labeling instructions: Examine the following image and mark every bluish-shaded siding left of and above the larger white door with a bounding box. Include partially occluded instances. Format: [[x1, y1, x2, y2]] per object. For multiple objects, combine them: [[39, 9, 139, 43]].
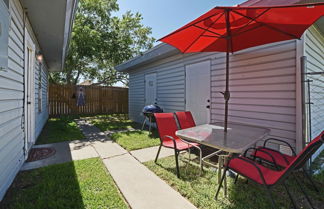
[[129, 53, 215, 122]]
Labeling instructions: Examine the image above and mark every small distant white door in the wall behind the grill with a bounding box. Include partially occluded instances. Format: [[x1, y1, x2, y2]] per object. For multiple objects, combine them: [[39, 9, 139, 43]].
[[145, 73, 157, 105]]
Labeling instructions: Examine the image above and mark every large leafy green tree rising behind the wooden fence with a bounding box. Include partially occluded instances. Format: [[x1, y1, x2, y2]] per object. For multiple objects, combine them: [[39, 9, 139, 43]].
[[50, 0, 155, 85]]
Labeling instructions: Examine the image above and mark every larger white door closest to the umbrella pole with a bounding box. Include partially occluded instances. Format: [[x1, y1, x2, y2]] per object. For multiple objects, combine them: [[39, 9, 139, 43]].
[[186, 60, 210, 125]]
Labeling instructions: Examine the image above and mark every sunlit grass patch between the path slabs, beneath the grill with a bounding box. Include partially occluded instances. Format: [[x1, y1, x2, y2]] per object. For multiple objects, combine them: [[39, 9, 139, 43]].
[[111, 131, 160, 151]]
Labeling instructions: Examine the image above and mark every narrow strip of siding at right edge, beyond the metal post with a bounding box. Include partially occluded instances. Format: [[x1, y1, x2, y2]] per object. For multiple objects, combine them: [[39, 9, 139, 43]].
[[304, 27, 324, 157]]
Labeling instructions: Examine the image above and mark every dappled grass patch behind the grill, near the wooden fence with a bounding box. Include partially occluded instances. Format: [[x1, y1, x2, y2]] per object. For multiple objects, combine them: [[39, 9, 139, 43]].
[[91, 114, 141, 131]]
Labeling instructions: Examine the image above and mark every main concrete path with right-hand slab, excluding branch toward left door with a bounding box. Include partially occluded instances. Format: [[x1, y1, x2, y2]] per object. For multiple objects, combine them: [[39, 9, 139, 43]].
[[78, 121, 196, 209]]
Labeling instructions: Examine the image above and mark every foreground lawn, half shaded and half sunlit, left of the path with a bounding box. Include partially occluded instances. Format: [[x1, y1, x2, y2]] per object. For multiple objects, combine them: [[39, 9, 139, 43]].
[[0, 158, 128, 209]]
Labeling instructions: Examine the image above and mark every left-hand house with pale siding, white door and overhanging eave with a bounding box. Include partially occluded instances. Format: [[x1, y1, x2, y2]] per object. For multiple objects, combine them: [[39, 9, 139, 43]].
[[0, 0, 77, 200]]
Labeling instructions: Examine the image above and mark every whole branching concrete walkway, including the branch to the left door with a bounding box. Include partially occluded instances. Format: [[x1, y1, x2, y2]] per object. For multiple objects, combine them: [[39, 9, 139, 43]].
[[23, 120, 196, 209]]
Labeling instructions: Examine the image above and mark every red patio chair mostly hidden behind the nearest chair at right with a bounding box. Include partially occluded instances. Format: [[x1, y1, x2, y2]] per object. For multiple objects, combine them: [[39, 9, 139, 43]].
[[253, 131, 324, 192]]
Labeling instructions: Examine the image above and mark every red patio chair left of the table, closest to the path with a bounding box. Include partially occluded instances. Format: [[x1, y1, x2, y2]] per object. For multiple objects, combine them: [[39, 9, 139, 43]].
[[154, 113, 201, 178]]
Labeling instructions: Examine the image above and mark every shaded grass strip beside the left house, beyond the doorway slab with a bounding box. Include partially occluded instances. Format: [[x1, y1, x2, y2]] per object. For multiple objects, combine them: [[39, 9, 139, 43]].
[[36, 116, 84, 144]]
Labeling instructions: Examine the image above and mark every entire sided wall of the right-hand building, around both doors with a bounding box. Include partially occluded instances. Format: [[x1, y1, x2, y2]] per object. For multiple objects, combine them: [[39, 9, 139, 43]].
[[129, 41, 296, 149]]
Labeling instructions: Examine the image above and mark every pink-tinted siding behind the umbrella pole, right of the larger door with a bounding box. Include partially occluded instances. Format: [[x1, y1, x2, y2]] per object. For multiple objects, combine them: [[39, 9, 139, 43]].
[[211, 41, 296, 149]]
